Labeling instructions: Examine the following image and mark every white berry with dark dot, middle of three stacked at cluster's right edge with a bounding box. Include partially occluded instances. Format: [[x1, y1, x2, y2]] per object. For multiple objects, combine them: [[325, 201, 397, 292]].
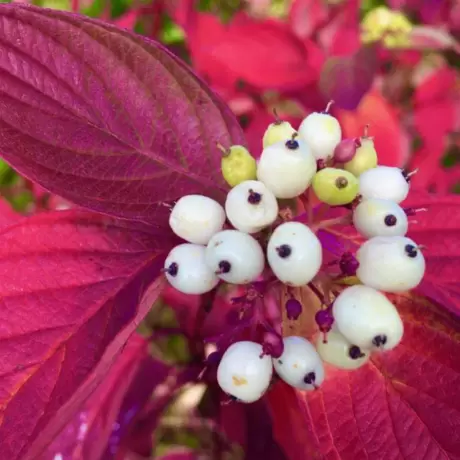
[[353, 199, 409, 238]]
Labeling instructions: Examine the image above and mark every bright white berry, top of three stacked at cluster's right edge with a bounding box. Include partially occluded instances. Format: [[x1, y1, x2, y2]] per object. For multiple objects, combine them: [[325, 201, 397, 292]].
[[359, 166, 409, 203]]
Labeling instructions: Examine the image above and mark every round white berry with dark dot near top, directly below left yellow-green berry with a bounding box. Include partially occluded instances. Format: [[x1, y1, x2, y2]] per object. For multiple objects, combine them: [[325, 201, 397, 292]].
[[225, 180, 278, 233]]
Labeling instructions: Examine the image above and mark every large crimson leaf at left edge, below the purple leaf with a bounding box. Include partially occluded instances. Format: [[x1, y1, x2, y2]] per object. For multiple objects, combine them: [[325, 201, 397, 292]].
[[0, 211, 170, 460]]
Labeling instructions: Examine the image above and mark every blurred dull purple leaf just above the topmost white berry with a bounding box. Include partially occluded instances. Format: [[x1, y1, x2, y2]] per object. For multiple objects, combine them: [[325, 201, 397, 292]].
[[320, 46, 378, 110]]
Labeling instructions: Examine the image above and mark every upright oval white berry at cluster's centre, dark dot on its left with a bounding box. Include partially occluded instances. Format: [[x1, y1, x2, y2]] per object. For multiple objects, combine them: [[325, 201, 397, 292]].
[[267, 222, 323, 286]]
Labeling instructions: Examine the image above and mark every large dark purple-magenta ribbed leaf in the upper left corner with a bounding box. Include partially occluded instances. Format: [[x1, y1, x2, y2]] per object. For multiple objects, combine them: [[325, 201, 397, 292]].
[[0, 4, 244, 226]]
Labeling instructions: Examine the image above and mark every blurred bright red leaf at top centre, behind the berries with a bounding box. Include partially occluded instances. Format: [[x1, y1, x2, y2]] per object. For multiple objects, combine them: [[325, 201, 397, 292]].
[[183, 13, 317, 90]]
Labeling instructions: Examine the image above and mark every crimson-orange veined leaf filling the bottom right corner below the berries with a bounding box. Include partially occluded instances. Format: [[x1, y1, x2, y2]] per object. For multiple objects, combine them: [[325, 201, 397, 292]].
[[269, 298, 460, 460]]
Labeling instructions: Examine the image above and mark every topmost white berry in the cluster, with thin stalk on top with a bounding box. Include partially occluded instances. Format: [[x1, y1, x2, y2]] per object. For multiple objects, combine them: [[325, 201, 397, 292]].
[[299, 112, 342, 160]]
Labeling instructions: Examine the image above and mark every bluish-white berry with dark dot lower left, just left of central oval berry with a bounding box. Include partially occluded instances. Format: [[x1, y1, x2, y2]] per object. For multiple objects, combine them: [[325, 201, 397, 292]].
[[205, 230, 265, 284]]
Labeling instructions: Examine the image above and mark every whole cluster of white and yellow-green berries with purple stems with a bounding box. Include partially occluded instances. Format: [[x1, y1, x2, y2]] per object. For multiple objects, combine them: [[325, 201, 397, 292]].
[[164, 105, 425, 403]]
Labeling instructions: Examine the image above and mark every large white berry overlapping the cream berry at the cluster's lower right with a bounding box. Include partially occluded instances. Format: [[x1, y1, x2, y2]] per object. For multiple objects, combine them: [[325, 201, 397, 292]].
[[332, 285, 404, 350]]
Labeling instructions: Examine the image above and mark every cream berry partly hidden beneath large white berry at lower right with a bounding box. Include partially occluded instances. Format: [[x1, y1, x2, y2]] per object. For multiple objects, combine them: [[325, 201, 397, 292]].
[[316, 329, 370, 369]]
